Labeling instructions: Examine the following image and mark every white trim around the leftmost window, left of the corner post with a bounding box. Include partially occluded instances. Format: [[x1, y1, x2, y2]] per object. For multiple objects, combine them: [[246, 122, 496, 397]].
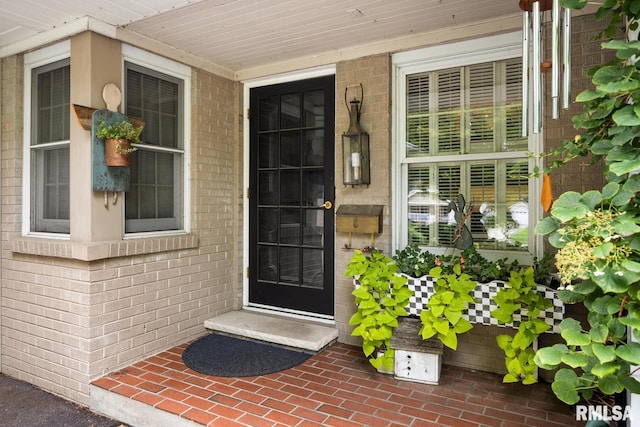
[[22, 40, 71, 240]]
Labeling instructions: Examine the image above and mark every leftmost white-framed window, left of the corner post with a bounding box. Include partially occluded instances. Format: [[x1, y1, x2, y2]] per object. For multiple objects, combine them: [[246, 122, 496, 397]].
[[24, 43, 71, 234]]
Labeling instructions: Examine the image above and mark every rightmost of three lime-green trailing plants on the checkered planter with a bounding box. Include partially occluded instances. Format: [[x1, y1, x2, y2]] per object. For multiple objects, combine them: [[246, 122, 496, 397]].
[[491, 267, 553, 384]]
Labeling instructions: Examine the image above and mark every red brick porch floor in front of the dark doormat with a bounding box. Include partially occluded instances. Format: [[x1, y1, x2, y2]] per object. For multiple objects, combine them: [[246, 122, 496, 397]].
[[93, 343, 580, 427]]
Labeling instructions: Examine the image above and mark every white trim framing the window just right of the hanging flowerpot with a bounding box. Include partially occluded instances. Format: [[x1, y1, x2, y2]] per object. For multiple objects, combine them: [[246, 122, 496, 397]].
[[120, 44, 191, 239]]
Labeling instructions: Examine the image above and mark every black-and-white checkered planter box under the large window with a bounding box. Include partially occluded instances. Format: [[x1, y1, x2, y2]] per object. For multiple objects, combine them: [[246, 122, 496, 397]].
[[406, 276, 564, 333]]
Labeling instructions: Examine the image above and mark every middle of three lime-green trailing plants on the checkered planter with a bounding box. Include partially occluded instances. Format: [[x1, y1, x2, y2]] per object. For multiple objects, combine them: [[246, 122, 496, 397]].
[[419, 264, 476, 350]]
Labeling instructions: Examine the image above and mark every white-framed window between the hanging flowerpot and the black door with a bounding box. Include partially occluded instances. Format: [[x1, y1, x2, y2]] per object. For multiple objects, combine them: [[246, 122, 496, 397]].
[[124, 49, 189, 233]]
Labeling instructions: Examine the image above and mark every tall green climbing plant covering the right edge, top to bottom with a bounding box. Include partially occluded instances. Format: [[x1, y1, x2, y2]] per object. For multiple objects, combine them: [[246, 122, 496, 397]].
[[535, 0, 640, 404]]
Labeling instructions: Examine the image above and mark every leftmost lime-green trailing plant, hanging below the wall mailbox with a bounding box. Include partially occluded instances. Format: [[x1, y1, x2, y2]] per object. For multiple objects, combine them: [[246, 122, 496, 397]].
[[345, 249, 413, 371]]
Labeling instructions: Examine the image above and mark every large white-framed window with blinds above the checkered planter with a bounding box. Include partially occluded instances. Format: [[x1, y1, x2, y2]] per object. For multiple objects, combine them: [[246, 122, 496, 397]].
[[396, 33, 537, 260]]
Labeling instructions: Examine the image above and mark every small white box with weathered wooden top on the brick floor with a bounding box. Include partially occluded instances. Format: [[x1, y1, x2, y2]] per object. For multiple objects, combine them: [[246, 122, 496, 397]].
[[391, 318, 443, 385]]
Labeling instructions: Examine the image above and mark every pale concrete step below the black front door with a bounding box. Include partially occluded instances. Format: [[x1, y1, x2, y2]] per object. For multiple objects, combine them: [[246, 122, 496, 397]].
[[204, 310, 338, 352]]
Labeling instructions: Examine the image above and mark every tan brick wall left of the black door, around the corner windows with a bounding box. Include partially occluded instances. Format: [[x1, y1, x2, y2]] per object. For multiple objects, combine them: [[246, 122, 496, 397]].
[[1, 49, 242, 404]]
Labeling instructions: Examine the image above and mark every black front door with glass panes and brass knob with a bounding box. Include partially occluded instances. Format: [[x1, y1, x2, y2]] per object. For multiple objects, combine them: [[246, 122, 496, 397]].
[[249, 76, 335, 316]]
